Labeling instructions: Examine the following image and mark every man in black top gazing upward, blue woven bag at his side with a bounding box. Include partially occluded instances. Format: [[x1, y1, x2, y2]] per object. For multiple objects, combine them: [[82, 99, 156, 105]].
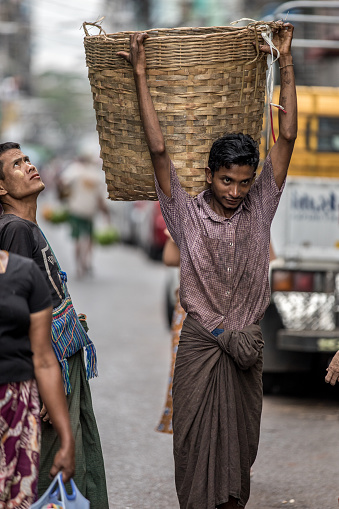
[[0, 142, 108, 509]]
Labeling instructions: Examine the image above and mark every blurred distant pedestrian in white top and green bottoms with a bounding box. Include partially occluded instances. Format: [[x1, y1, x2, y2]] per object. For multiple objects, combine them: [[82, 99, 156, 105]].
[[59, 155, 110, 278]]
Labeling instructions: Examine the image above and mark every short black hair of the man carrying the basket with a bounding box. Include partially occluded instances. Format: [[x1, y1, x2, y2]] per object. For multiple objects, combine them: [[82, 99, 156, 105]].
[[208, 133, 259, 176]]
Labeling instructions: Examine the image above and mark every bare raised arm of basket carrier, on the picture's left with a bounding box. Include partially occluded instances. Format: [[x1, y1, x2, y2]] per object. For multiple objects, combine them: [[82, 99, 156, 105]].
[[117, 33, 171, 196]]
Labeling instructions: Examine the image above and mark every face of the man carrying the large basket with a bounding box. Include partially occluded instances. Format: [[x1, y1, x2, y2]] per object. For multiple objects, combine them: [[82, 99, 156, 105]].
[[206, 164, 255, 215]]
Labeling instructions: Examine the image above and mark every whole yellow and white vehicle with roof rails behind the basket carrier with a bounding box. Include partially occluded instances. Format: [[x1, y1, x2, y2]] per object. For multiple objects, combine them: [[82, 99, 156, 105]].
[[261, 0, 339, 392]]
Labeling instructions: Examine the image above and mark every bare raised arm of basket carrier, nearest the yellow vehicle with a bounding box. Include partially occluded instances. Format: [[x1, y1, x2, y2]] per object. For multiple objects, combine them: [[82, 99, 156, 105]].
[[260, 23, 298, 189]]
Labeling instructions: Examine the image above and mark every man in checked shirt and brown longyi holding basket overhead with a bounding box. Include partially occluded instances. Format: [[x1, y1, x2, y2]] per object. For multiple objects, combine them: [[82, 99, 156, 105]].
[[118, 23, 297, 509]]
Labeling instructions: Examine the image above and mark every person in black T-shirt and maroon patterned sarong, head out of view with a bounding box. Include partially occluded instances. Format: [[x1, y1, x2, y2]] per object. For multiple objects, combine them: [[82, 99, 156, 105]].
[[0, 250, 75, 509]]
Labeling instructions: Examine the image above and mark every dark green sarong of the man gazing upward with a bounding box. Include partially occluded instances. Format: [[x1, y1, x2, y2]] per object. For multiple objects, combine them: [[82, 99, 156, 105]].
[[38, 350, 109, 509]]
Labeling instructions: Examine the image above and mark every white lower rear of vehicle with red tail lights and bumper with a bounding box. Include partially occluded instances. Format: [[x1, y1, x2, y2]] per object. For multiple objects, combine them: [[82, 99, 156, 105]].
[[261, 177, 339, 392]]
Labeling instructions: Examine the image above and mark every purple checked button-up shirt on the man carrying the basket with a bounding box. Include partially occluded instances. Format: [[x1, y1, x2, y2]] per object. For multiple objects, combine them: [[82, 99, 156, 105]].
[[155, 155, 284, 331]]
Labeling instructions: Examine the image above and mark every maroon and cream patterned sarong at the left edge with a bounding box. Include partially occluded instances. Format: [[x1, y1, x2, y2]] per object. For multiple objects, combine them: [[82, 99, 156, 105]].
[[0, 380, 40, 509]]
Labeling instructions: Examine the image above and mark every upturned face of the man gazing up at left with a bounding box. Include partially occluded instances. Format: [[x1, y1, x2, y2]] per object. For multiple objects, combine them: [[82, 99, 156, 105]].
[[0, 148, 45, 200]]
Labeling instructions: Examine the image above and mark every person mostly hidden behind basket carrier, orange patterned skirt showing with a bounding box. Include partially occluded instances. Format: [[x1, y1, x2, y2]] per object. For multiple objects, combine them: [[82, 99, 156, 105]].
[[156, 229, 186, 434]]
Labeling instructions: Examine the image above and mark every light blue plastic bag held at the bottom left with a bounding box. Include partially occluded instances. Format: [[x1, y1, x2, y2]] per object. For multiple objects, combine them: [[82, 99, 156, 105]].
[[30, 472, 90, 509]]
